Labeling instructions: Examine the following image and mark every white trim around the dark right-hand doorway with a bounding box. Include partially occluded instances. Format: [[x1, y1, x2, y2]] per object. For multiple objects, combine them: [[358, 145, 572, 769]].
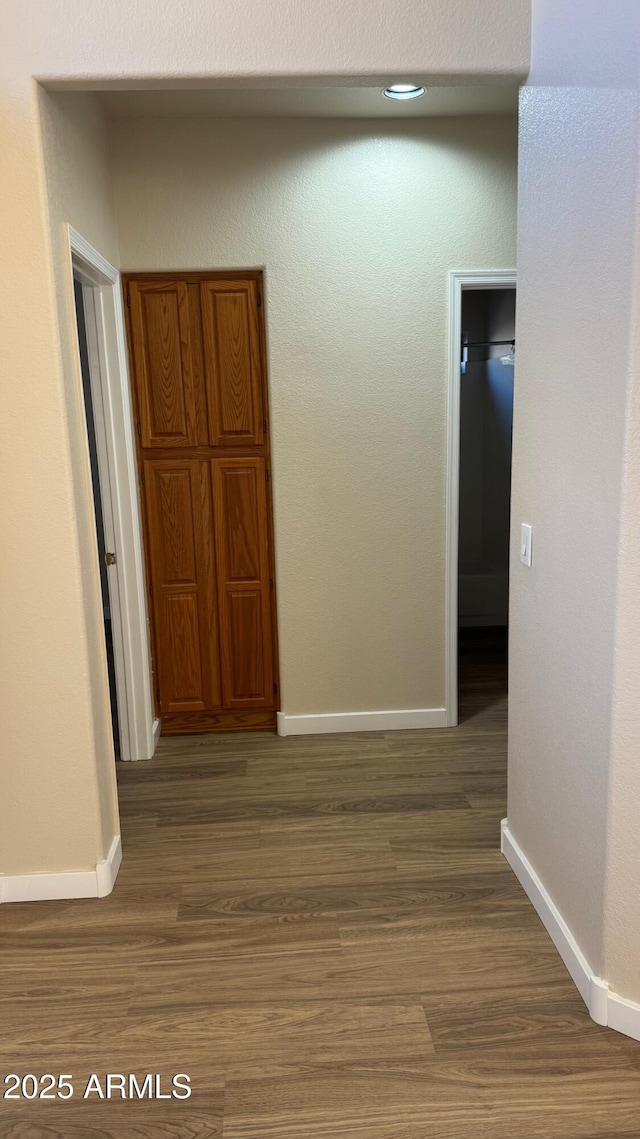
[[444, 269, 516, 728]]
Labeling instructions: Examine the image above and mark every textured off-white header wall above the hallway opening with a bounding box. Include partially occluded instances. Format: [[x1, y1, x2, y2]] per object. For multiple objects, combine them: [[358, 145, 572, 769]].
[[11, 0, 531, 87]]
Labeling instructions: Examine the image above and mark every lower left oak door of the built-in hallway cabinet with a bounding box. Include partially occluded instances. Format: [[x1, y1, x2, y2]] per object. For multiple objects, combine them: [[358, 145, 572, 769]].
[[143, 459, 221, 714]]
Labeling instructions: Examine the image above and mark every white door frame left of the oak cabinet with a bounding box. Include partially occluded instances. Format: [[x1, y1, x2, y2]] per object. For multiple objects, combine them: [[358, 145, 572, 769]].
[[66, 226, 159, 760]]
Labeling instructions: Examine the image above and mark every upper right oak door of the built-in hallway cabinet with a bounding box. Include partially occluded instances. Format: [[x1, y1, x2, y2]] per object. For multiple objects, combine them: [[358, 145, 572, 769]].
[[200, 280, 264, 446]]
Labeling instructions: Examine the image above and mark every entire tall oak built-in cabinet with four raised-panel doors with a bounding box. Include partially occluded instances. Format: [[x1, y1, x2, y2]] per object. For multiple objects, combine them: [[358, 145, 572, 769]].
[[126, 274, 277, 731]]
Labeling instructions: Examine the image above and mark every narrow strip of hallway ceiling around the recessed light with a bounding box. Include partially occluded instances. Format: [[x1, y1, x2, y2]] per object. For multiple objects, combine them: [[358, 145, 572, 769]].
[[99, 84, 518, 118]]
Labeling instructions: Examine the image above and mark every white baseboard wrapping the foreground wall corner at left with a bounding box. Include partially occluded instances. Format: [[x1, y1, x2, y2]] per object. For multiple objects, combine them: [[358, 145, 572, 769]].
[[0, 835, 122, 902]]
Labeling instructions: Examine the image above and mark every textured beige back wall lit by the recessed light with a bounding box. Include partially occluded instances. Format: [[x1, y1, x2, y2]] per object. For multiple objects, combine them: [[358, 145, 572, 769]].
[[112, 118, 516, 714]]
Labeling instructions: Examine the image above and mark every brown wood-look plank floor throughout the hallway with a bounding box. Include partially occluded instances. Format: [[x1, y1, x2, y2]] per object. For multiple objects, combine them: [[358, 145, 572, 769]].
[[0, 638, 640, 1139]]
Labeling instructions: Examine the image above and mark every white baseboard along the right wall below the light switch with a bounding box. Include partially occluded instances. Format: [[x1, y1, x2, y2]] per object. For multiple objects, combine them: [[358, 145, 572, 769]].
[[501, 819, 640, 1040]]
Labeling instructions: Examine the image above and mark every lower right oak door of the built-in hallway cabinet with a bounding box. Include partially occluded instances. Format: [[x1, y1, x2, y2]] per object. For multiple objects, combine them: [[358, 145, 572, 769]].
[[211, 458, 273, 708]]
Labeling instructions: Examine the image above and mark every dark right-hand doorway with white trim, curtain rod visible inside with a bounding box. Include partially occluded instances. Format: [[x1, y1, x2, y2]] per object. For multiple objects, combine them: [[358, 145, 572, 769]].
[[448, 273, 516, 724]]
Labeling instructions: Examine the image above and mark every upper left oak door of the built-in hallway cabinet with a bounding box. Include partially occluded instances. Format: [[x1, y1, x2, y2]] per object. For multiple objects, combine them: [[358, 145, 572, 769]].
[[129, 280, 198, 448]]
